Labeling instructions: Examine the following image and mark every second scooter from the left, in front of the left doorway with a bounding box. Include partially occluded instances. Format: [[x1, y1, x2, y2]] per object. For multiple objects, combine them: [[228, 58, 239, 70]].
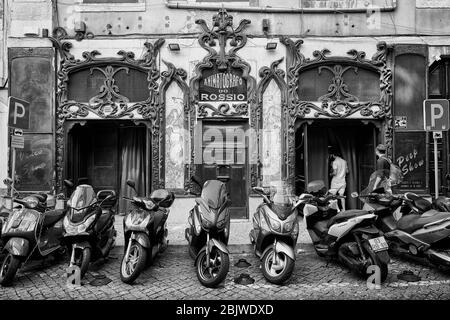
[[63, 180, 117, 278]]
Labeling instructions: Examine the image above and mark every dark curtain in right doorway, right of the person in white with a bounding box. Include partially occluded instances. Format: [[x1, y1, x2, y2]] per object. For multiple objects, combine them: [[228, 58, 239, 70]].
[[328, 128, 359, 209]]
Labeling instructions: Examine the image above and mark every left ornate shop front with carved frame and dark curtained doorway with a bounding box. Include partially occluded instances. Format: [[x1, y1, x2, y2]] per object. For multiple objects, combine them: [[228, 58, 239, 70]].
[[56, 40, 163, 213]]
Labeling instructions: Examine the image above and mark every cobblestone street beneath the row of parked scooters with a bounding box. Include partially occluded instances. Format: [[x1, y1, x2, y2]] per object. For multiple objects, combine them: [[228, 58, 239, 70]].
[[0, 244, 450, 300]]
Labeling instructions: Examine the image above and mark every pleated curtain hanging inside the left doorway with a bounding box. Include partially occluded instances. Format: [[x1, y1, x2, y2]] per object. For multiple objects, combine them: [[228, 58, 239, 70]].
[[119, 127, 147, 214]]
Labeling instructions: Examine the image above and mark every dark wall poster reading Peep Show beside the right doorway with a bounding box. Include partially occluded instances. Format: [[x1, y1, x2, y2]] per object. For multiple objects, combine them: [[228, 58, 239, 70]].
[[393, 131, 427, 190]]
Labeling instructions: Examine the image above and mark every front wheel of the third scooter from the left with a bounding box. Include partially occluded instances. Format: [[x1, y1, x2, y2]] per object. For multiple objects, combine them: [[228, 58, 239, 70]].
[[120, 240, 147, 284]]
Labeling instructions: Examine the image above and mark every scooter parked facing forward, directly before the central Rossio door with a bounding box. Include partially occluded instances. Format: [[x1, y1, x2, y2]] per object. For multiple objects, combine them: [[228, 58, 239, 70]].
[[185, 176, 231, 288]]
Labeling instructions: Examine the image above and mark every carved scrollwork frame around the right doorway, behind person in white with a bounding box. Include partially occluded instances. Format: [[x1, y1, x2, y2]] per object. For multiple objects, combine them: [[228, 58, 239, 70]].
[[280, 37, 393, 185]]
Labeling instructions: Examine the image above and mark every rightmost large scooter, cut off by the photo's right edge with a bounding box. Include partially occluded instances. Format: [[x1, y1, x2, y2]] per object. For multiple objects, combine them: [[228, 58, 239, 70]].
[[352, 184, 450, 268]]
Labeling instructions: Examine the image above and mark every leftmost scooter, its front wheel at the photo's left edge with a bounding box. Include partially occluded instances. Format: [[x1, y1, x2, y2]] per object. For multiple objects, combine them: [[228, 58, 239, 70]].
[[0, 190, 65, 286]]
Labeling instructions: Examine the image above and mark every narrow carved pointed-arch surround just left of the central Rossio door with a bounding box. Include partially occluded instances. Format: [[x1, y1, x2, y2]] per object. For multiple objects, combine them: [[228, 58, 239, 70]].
[[159, 60, 191, 191]]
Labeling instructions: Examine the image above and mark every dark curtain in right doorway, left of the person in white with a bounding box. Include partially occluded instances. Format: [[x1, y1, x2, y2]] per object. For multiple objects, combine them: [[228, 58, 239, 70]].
[[307, 127, 329, 187]]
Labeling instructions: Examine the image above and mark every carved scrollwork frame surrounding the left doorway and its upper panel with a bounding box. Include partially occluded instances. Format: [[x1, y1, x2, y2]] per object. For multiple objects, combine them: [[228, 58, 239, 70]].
[[50, 31, 164, 190]]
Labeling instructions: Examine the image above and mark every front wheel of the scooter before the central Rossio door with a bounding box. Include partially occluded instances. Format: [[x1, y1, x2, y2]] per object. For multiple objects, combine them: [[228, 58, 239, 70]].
[[196, 247, 230, 288]]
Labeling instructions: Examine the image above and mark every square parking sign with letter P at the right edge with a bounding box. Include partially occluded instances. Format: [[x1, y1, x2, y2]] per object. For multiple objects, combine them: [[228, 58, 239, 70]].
[[423, 99, 450, 131]]
